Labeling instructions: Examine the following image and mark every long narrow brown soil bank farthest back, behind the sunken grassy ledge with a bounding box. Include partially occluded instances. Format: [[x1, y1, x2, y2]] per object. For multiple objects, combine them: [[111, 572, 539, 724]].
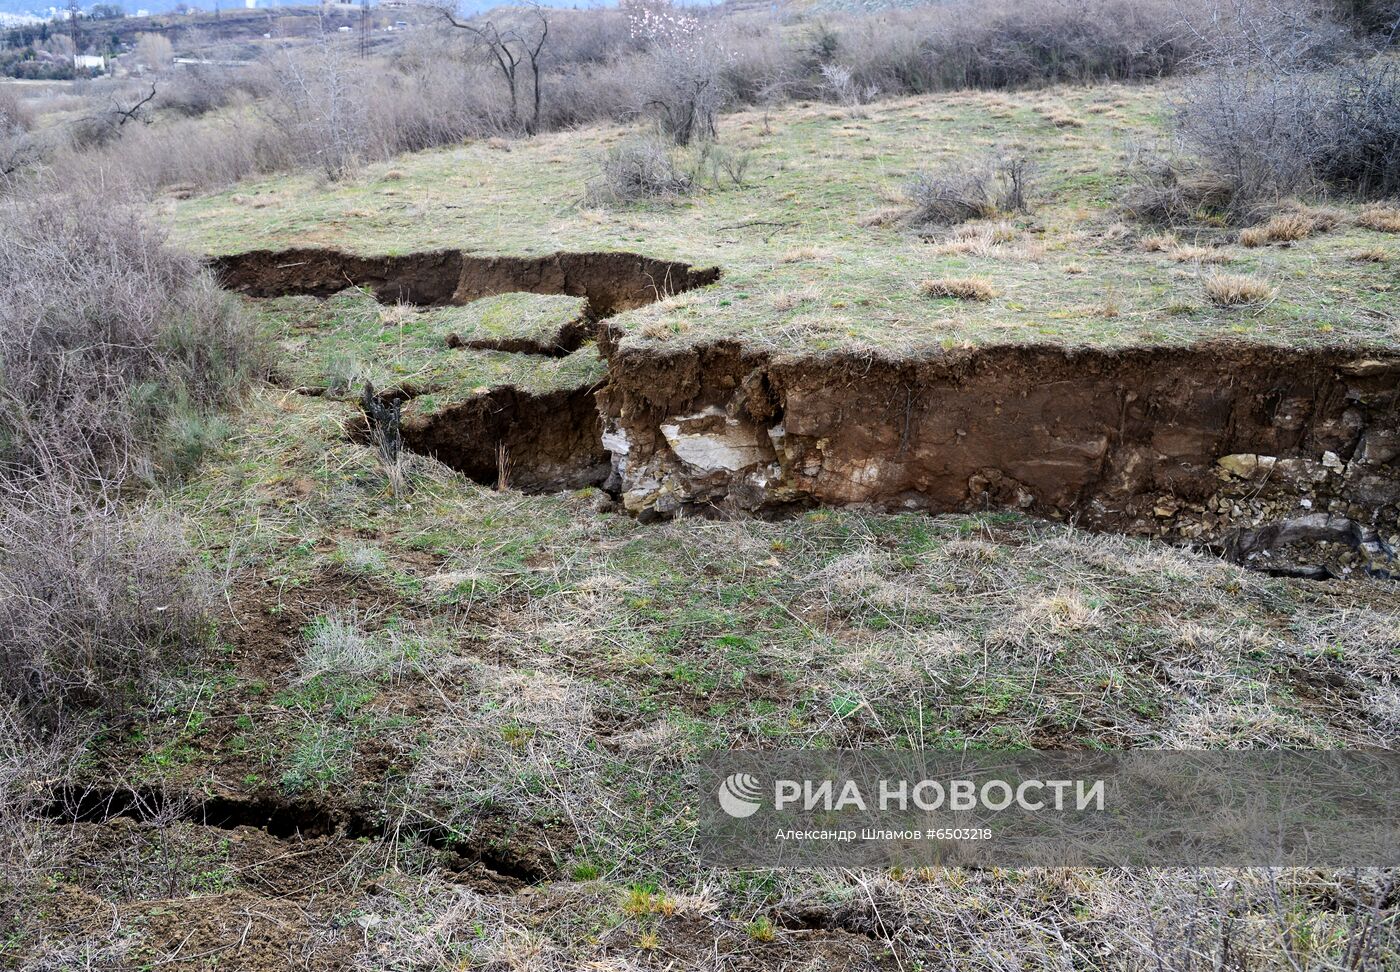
[[210, 248, 720, 318]]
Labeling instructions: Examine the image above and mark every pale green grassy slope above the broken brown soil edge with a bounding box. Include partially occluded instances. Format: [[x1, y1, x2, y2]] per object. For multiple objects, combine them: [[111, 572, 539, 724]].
[[168, 85, 1400, 353]]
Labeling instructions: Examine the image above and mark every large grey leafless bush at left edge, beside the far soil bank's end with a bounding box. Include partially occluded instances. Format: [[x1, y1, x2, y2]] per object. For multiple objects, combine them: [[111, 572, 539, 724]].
[[0, 195, 258, 482]]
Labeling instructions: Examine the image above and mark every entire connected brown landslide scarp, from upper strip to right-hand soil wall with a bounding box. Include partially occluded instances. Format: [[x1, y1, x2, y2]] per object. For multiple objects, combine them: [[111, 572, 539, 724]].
[[214, 251, 1400, 577]]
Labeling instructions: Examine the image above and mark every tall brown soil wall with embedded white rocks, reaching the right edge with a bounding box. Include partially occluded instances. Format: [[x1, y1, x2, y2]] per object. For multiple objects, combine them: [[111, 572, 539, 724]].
[[599, 343, 1400, 571]]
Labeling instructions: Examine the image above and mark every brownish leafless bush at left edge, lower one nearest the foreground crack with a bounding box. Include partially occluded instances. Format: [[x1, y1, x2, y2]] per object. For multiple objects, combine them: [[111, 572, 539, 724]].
[[0, 478, 211, 718]]
